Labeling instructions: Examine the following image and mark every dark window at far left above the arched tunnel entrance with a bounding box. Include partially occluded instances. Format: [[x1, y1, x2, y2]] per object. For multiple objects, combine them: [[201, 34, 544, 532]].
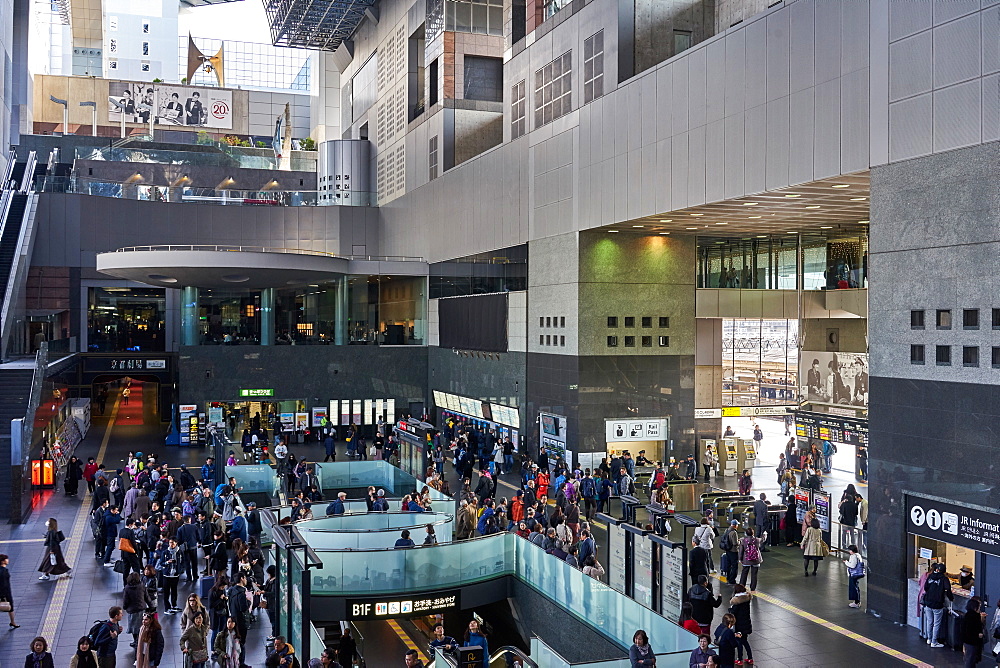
[[87, 287, 166, 352]]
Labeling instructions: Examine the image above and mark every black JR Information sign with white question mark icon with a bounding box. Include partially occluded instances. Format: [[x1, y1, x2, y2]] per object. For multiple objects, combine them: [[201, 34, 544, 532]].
[[906, 495, 1000, 556]]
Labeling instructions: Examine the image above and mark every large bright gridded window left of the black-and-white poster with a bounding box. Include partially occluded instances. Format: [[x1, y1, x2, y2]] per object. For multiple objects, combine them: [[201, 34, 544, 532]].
[[722, 318, 799, 406]]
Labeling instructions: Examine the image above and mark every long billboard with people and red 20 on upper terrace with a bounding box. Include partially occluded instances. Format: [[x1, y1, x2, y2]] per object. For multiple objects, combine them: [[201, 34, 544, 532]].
[[108, 81, 233, 130]]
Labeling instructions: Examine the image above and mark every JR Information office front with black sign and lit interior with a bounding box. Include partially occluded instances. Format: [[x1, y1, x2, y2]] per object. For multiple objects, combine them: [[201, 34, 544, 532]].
[[905, 494, 1000, 638]]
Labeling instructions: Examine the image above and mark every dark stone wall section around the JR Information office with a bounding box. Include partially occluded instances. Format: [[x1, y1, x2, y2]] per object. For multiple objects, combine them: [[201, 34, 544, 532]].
[[867, 376, 1000, 621]]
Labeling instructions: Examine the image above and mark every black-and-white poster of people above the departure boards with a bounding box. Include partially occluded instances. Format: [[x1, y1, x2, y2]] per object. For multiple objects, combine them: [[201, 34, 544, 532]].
[[799, 350, 868, 406]]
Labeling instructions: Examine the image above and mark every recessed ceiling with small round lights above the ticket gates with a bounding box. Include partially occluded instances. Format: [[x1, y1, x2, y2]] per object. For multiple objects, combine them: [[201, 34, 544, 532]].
[[602, 172, 870, 237]]
